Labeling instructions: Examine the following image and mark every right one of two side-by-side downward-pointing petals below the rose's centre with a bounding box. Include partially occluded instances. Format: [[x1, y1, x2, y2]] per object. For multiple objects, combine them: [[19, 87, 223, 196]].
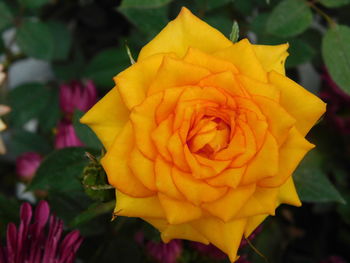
[[202, 184, 255, 222]]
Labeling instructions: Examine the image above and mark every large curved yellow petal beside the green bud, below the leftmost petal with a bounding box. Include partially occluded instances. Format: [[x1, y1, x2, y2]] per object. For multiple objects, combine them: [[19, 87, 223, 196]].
[[101, 122, 154, 197]]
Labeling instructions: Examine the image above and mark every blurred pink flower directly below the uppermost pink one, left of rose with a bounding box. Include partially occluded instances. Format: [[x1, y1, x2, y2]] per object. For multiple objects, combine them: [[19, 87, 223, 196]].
[[55, 119, 83, 149]]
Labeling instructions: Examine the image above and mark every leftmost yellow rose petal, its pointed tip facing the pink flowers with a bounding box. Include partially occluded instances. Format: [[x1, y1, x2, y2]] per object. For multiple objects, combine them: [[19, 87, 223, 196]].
[[80, 87, 129, 150]]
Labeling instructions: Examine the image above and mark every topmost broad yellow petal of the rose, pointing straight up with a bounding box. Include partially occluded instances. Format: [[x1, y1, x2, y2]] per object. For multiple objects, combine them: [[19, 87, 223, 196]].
[[138, 7, 232, 61]]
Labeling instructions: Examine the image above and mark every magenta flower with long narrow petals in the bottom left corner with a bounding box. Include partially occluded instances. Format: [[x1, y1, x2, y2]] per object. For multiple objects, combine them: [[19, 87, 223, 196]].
[[0, 201, 83, 263]]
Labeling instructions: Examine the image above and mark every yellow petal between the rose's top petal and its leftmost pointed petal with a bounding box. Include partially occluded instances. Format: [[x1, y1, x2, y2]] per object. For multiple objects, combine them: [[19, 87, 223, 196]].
[[114, 54, 164, 109]]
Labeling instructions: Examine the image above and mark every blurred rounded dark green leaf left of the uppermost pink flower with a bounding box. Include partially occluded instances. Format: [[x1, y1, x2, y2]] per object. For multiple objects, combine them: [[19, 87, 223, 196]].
[[9, 83, 50, 127]]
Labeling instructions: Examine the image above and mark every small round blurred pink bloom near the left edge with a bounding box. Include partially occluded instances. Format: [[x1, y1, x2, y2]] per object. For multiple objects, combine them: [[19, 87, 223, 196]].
[[16, 152, 42, 180]]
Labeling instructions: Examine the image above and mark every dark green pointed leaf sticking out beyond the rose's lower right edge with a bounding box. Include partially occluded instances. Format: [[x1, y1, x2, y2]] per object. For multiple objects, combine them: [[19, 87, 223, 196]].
[[293, 150, 345, 204]]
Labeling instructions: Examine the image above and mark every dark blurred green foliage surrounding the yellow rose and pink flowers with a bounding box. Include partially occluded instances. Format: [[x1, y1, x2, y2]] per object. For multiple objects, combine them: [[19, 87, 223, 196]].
[[0, 0, 350, 263]]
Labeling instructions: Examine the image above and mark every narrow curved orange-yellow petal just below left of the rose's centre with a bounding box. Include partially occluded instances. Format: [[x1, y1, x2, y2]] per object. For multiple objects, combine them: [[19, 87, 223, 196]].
[[154, 156, 185, 200]]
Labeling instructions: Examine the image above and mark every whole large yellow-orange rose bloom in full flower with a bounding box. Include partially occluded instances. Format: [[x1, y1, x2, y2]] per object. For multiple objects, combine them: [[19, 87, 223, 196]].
[[81, 8, 325, 261]]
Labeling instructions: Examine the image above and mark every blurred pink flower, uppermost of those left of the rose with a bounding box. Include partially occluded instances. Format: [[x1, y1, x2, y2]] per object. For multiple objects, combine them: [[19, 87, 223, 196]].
[[60, 80, 97, 114]]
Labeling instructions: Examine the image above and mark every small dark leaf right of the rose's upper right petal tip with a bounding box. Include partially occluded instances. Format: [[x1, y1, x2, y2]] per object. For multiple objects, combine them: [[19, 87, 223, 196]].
[[286, 39, 315, 68]]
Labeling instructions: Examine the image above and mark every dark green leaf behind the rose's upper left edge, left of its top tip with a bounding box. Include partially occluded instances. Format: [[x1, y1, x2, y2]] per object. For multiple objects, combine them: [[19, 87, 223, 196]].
[[118, 6, 168, 38]]
